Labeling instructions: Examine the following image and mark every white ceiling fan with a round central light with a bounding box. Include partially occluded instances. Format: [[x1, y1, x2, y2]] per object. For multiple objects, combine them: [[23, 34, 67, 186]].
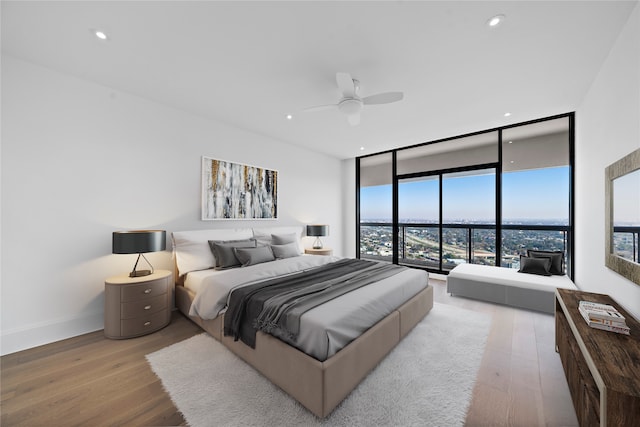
[[304, 73, 404, 126]]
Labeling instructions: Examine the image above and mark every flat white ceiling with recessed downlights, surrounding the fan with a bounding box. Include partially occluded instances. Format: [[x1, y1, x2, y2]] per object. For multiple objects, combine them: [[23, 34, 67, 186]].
[[1, 0, 638, 158]]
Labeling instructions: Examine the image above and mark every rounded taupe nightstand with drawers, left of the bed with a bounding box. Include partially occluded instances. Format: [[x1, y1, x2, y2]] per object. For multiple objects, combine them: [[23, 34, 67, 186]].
[[104, 270, 173, 339]]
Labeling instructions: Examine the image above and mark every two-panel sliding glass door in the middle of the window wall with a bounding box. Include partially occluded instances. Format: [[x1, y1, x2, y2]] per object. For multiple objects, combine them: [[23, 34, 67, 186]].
[[398, 168, 496, 271]]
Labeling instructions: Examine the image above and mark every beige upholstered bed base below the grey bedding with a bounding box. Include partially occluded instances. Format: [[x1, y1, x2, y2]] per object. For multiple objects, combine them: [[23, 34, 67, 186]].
[[175, 274, 433, 418]]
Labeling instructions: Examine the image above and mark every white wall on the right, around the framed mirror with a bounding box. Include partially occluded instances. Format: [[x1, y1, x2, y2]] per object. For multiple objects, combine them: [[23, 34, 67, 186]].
[[575, 5, 640, 318]]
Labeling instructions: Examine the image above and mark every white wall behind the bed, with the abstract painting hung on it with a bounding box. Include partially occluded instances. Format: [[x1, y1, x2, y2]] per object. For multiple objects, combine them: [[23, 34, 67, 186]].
[[0, 55, 343, 354]]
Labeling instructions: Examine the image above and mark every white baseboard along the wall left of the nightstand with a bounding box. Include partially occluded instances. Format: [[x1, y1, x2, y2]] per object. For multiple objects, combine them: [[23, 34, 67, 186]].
[[0, 312, 104, 356]]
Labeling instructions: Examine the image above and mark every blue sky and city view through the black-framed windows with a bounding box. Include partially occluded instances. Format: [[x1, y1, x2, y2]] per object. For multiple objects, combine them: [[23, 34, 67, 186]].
[[360, 166, 569, 271]]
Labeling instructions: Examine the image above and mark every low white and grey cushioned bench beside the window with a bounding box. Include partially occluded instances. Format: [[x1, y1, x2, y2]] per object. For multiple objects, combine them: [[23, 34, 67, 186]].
[[447, 264, 578, 314]]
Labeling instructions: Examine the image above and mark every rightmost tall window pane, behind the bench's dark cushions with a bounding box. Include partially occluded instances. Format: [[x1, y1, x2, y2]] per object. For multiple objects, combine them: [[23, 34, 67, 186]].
[[501, 117, 571, 274]]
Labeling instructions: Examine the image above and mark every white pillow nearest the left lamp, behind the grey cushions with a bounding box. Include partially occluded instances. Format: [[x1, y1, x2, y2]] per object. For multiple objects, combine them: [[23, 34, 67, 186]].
[[171, 228, 253, 276]]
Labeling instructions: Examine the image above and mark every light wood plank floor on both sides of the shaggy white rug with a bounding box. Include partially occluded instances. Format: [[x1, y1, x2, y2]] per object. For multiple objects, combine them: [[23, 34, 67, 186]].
[[0, 280, 578, 427]]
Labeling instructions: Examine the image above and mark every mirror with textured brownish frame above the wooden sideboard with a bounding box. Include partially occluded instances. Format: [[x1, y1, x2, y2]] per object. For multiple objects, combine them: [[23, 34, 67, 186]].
[[605, 149, 640, 285]]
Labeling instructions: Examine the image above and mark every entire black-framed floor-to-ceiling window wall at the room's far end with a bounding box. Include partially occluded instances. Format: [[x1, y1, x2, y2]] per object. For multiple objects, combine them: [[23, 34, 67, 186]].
[[357, 114, 573, 273]]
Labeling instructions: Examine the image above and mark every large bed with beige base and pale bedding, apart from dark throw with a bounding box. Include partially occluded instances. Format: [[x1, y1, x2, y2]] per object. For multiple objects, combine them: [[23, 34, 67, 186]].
[[172, 226, 433, 418]]
